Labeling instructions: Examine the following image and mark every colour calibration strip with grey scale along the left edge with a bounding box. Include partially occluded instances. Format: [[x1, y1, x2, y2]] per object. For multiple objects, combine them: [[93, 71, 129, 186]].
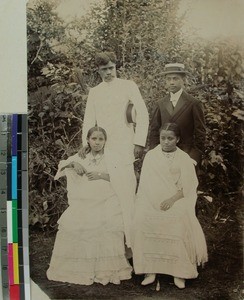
[[0, 114, 30, 300]]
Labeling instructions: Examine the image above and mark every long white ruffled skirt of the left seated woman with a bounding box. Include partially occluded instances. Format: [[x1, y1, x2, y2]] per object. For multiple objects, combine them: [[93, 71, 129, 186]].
[[47, 172, 132, 285]]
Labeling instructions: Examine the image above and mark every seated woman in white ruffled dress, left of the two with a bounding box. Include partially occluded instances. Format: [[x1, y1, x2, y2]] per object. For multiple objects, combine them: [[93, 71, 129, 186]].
[[47, 127, 132, 285]]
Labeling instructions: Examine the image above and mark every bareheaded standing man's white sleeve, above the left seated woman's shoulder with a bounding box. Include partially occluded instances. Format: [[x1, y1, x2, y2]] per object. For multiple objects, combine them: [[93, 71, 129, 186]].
[[82, 88, 96, 146]]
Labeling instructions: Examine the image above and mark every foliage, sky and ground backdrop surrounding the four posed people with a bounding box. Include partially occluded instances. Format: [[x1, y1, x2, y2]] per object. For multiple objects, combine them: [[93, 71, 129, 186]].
[[27, 0, 244, 299]]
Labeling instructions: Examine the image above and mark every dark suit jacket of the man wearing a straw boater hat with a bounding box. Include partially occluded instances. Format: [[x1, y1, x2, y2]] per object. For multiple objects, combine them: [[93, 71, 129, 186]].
[[149, 91, 206, 162]]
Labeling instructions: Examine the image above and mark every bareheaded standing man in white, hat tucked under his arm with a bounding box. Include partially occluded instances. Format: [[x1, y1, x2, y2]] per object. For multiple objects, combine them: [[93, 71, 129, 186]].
[[82, 52, 149, 193]]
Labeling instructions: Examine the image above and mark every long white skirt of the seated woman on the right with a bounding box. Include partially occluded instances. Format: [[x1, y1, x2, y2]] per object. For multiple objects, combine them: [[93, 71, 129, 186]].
[[133, 199, 207, 279]]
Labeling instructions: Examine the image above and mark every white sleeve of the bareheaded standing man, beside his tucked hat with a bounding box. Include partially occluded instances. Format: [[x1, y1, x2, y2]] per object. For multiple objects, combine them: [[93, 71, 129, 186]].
[[129, 81, 149, 147]]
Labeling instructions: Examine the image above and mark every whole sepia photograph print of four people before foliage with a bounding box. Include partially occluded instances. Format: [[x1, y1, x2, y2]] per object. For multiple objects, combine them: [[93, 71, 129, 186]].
[[26, 0, 244, 300]]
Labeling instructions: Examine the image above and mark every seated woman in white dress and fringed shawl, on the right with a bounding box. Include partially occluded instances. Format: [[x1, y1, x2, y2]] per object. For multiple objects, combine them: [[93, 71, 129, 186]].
[[132, 123, 208, 288]]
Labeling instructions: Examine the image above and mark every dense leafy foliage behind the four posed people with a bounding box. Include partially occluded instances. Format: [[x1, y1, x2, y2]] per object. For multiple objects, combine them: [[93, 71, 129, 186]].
[[27, 0, 244, 234]]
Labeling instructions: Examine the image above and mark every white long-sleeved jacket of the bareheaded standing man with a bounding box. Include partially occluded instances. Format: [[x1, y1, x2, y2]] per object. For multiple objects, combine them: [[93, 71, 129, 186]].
[[82, 78, 149, 165]]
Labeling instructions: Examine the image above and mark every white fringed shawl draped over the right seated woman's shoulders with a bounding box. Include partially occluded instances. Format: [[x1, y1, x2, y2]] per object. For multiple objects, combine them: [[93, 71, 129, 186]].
[[136, 145, 208, 265]]
